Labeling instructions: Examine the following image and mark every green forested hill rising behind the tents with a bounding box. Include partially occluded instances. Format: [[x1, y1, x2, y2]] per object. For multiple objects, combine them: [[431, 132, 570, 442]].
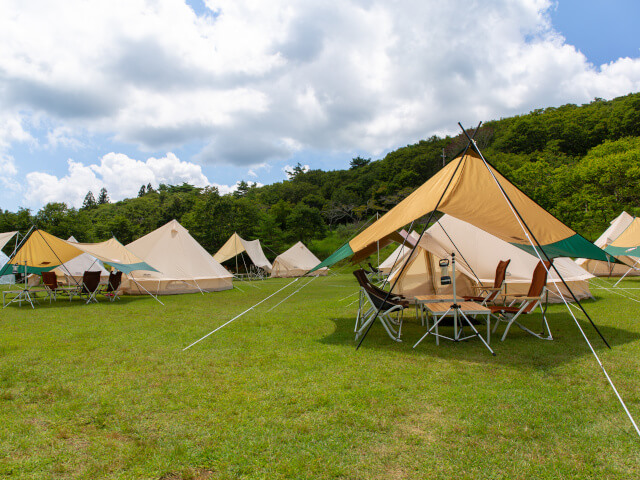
[[0, 94, 640, 257]]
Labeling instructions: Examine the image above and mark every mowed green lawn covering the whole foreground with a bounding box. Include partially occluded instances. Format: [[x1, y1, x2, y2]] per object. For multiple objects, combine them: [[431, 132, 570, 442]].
[[0, 274, 640, 480]]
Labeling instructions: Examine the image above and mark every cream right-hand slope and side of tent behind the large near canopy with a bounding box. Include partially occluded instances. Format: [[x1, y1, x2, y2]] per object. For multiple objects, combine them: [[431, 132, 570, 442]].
[[427, 215, 593, 302]]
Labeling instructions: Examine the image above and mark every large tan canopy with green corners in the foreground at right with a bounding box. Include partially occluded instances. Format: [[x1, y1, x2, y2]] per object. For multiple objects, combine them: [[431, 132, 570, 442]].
[[315, 150, 612, 269]]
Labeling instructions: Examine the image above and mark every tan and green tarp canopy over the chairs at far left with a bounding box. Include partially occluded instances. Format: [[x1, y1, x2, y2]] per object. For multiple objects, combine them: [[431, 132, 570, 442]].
[[0, 229, 155, 275]]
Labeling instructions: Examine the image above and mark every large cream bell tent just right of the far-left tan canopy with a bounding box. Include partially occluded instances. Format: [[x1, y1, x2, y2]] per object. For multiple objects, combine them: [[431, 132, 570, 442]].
[[122, 220, 233, 295]]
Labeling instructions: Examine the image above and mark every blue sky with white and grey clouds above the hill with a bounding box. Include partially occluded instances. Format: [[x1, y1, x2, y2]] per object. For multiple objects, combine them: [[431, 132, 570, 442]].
[[0, 0, 640, 210]]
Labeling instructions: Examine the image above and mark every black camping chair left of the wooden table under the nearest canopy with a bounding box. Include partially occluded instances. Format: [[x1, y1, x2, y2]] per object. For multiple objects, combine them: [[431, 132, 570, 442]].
[[353, 270, 409, 342]]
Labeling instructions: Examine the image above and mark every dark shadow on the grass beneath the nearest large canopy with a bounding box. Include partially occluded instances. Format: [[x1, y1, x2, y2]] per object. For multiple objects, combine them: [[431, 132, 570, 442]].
[[319, 312, 640, 368]]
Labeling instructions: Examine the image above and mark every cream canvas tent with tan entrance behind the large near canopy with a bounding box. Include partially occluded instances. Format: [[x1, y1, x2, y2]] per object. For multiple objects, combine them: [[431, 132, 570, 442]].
[[391, 215, 593, 303]]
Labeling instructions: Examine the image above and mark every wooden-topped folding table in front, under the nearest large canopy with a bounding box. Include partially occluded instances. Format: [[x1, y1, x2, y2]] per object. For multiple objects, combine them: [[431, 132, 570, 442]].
[[413, 302, 495, 355]]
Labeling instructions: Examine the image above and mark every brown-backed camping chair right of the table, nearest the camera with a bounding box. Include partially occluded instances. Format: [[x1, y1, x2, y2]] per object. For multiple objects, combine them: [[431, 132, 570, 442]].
[[489, 262, 553, 341]]
